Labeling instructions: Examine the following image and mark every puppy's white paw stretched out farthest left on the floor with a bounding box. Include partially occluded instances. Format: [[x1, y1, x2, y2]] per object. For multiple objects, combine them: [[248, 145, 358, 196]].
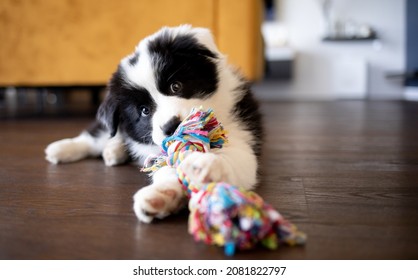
[[45, 138, 89, 164]]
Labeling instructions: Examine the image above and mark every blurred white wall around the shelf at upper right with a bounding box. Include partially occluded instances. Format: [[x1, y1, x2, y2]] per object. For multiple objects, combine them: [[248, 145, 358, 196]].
[[279, 0, 405, 99]]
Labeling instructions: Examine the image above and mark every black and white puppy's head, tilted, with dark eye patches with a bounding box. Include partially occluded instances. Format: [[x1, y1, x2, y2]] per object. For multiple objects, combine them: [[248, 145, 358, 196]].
[[98, 25, 222, 145]]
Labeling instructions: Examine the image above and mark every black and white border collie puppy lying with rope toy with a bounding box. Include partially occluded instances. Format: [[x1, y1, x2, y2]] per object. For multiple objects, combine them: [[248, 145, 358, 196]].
[[45, 25, 262, 223]]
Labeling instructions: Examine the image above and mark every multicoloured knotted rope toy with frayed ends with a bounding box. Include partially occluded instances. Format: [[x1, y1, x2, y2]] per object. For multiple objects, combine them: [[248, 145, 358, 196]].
[[142, 109, 306, 256]]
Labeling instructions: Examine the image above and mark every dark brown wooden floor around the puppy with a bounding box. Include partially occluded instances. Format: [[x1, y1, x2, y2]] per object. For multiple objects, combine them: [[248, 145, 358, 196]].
[[0, 102, 418, 259]]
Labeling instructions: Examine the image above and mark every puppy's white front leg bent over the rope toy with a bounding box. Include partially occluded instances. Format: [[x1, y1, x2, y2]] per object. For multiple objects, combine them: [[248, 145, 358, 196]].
[[177, 136, 258, 190]]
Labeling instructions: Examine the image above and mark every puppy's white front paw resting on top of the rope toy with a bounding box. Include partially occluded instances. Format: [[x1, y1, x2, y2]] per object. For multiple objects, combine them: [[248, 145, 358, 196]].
[[180, 152, 228, 184]]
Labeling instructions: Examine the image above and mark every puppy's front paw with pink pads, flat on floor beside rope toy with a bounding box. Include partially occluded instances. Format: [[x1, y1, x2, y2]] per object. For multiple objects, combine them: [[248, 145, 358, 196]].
[[134, 181, 186, 223]]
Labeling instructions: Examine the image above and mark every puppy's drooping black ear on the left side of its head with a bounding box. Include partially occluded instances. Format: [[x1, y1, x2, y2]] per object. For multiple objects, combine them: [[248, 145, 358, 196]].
[[96, 92, 119, 137]]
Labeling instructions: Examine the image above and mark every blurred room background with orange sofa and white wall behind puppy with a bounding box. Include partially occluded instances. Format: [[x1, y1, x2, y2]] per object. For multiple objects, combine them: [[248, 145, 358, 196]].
[[0, 0, 418, 119]]
